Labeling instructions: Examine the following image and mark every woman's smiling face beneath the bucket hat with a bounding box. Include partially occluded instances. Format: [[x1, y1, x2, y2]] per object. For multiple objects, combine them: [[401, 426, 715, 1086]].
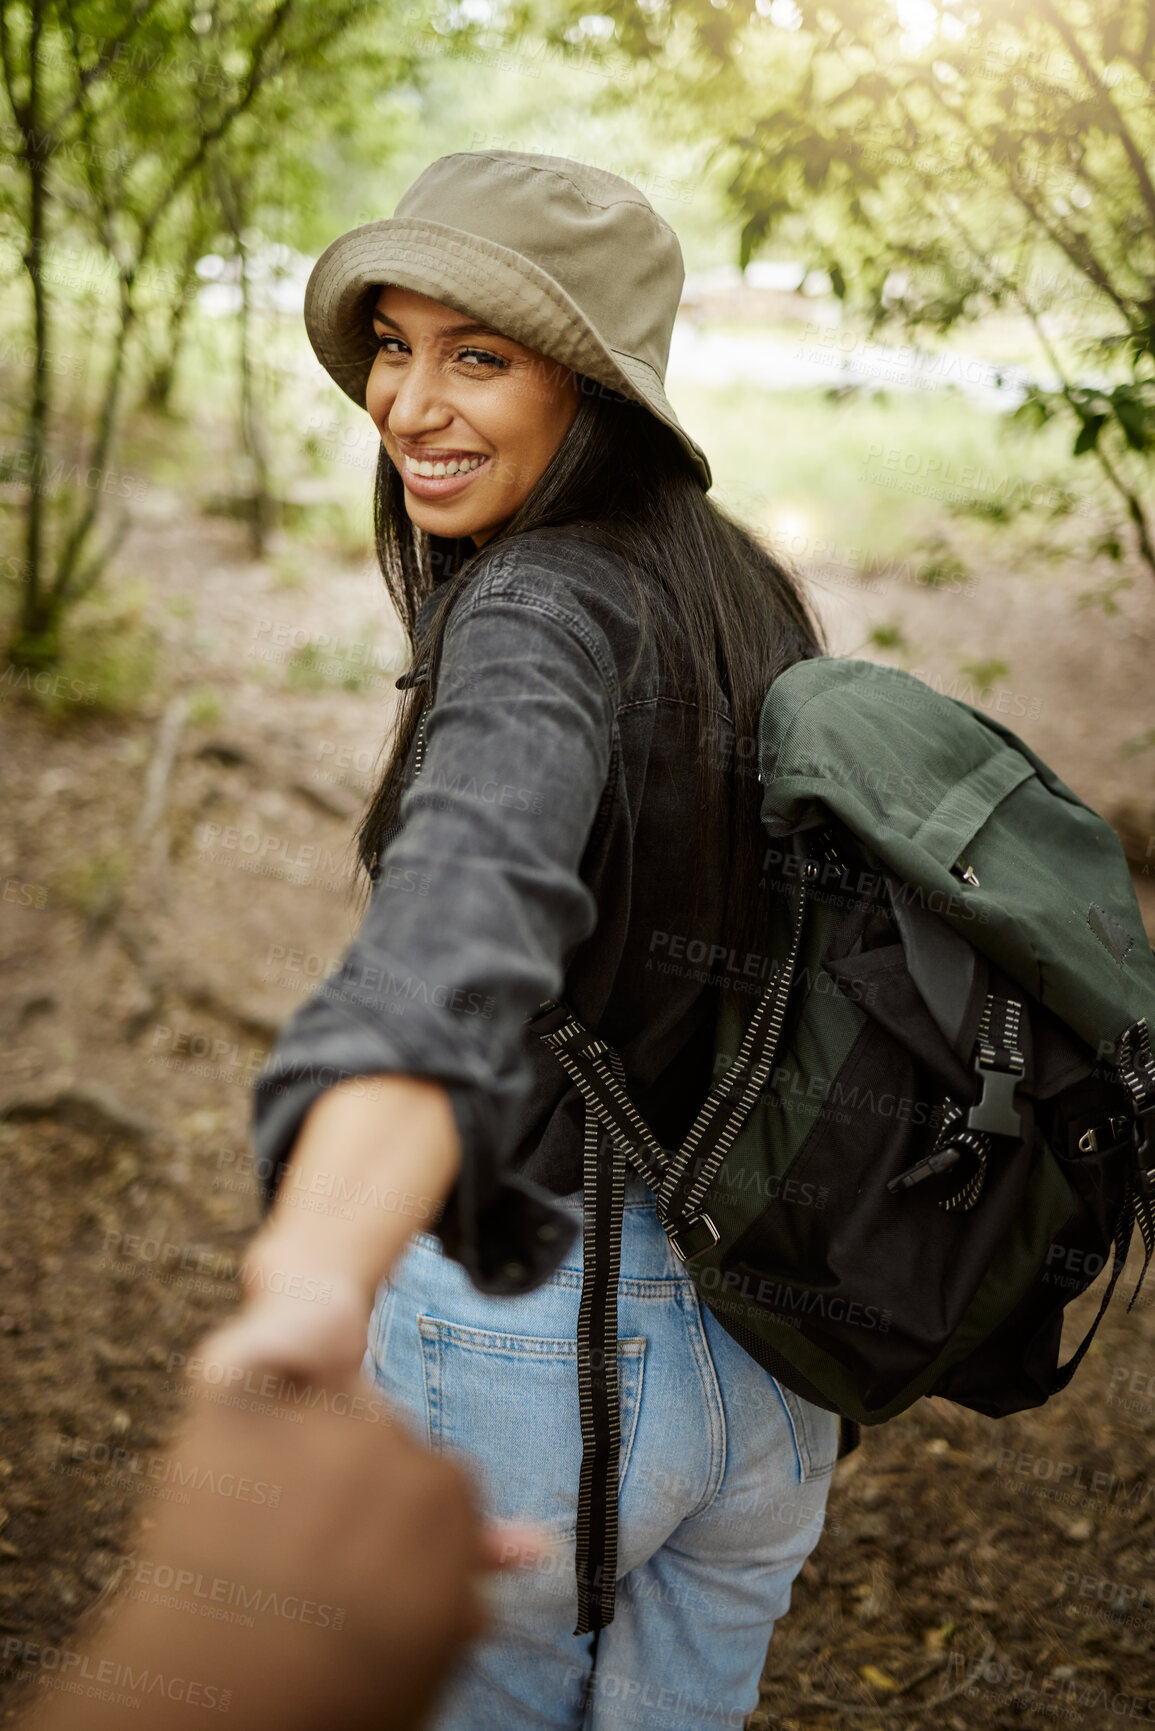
[[365, 284, 580, 547]]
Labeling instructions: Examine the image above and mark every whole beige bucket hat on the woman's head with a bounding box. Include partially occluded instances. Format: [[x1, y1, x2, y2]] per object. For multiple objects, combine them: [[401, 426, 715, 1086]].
[[305, 151, 713, 492]]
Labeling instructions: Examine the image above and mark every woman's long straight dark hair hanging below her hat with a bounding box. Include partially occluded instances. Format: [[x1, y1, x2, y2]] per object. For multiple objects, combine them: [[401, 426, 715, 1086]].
[[348, 376, 824, 1013]]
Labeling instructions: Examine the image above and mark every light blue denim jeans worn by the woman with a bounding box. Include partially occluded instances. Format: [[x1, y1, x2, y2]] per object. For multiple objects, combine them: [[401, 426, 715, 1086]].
[[364, 1174, 838, 1731]]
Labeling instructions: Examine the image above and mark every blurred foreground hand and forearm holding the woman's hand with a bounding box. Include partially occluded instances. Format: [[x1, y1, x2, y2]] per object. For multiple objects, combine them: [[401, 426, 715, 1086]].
[[35, 1329, 554, 1731]]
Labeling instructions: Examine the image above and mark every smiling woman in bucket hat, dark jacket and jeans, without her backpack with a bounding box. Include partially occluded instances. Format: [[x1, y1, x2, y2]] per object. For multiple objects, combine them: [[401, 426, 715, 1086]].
[[230, 151, 836, 1731]]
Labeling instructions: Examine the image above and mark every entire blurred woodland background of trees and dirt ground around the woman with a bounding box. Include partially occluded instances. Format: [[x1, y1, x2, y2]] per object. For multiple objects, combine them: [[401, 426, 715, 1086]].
[[0, 0, 1155, 1731]]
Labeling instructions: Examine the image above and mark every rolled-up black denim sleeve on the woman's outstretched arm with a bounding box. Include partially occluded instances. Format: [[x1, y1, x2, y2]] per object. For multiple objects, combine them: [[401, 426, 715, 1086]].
[[253, 561, 616, 1293]]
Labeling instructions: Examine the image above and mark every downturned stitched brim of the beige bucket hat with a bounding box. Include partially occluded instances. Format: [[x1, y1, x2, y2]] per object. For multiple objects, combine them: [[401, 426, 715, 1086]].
[[305, 216, 713, 492]]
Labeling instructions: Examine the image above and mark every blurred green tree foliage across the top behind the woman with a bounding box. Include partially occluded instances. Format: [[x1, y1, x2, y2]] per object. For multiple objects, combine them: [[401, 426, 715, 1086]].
[[0, 0, 1155, 666]]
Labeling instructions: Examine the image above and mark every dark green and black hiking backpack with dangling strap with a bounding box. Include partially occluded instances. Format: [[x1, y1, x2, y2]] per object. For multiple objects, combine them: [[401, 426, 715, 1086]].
[[530, 656, 1155, 1634]]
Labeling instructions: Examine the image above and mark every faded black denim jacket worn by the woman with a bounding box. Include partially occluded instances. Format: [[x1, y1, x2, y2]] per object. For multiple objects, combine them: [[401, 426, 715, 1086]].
[[253, 526, 744, 1293]]
